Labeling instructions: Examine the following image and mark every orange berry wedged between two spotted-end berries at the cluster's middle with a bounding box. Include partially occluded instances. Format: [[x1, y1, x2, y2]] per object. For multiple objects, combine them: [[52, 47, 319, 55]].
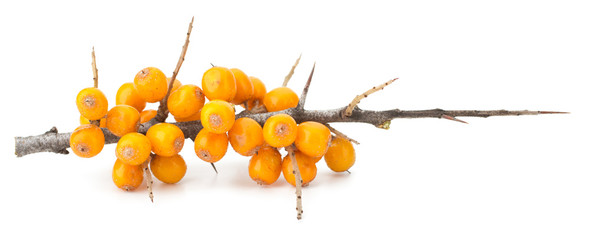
[[228, 118, 264, 156]]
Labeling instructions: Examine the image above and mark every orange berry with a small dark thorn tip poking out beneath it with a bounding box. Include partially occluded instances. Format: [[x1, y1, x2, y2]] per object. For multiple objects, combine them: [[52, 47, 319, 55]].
[[194, 128, 229, 163]]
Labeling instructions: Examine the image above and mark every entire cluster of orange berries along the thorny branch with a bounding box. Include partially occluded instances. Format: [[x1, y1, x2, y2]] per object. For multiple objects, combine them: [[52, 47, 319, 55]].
[[70, 66, 355, 190]]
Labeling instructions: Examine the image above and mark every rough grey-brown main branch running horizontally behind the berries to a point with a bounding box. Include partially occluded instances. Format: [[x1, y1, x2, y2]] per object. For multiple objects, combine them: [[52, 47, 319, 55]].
[[15, 107, 567, 157]]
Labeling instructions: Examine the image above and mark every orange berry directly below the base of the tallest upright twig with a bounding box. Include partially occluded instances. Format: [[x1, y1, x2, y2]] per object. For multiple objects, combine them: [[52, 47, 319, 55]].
[[145, 123, 184, 157]]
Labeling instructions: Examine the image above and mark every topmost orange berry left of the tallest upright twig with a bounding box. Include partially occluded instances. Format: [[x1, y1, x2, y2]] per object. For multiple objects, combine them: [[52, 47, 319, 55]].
[[133, 67, 168, 103]]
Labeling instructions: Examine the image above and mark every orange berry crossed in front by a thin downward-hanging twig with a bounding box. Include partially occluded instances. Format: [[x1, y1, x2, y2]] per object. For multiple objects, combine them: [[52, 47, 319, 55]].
[[282, 151, 317, 187]]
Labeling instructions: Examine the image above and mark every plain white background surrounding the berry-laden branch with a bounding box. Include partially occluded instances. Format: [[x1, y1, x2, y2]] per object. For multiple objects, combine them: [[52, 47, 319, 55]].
[[0, 0, 589, 239]]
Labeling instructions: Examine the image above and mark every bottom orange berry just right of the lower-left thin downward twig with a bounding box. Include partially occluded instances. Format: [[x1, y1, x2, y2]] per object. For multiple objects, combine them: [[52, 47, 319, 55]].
[[150, 155, 186, 184]]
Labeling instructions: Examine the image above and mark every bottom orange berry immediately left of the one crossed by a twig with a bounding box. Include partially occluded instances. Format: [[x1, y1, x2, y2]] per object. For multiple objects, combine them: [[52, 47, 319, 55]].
[[248, 147, 282, 185]]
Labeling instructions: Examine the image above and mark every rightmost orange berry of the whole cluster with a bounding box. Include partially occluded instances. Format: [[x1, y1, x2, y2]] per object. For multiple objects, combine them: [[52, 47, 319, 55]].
[[323, 137, 356, 172]]
